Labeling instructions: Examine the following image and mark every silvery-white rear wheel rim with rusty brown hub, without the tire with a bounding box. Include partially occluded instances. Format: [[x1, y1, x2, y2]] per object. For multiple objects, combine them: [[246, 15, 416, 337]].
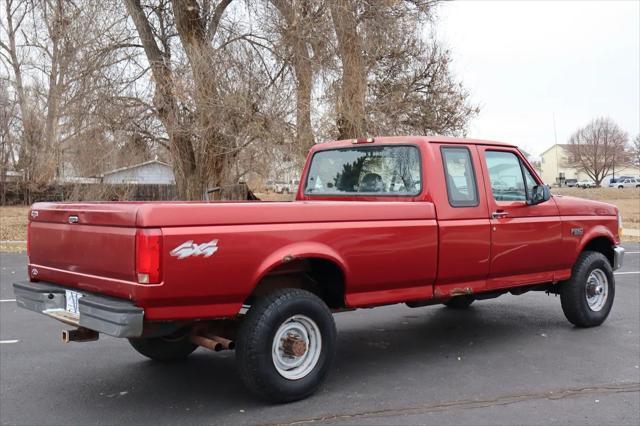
[[271, 315, 322, 380]]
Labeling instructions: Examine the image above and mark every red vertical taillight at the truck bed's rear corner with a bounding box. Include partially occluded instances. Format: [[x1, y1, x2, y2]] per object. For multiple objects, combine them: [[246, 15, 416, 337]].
[[136, 229, 162, 284]]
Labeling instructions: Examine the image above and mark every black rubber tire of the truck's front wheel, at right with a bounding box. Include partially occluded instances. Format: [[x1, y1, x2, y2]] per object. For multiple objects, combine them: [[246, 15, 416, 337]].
[[560, 251, 616, 327]]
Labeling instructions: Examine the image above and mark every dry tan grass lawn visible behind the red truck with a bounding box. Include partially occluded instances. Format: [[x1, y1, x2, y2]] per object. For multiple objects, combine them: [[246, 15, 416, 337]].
[[0, 188, 640, 252]]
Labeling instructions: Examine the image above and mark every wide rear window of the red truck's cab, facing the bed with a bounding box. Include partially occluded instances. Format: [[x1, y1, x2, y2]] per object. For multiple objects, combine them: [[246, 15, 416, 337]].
[[305, 146, 422, 195]]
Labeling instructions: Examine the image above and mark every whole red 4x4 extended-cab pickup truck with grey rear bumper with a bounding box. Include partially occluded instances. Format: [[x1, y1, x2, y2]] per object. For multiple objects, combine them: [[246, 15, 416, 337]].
[[14, 137, 624, 402]]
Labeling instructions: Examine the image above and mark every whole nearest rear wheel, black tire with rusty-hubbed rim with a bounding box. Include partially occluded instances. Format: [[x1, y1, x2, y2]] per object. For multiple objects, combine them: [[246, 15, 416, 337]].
[[236, 289, 336, 402]]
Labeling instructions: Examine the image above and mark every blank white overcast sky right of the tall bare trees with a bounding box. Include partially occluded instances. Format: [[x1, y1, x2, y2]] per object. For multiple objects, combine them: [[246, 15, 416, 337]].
[[437, 0, 640, 154]]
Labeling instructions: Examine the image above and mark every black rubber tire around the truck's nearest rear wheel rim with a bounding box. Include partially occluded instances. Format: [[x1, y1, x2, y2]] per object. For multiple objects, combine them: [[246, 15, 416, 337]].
[[236, 289, 336, 403]]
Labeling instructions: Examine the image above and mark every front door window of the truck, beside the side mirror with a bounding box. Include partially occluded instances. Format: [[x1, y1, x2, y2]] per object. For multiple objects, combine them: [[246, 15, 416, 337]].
[[485, 151, 536, 201]]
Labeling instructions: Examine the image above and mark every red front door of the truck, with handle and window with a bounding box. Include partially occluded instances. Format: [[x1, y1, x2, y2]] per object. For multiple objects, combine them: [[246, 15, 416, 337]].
[[478, 146, 562, 289]]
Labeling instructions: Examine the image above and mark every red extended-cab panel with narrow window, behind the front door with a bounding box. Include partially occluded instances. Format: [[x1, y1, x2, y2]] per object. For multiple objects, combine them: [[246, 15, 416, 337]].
[[428, 144, 491, 298]]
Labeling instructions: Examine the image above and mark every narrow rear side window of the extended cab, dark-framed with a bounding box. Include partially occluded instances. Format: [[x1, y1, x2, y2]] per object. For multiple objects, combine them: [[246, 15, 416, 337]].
[[441, 147, 478, 207]]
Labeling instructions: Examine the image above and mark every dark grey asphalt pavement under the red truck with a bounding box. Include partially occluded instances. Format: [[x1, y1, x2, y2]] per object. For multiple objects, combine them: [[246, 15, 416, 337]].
[[0, 244, 640, 425]]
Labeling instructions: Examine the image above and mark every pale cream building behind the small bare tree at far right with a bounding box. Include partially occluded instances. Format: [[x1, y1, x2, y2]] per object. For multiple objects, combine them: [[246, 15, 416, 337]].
[[540, 144, 640, 186]]
